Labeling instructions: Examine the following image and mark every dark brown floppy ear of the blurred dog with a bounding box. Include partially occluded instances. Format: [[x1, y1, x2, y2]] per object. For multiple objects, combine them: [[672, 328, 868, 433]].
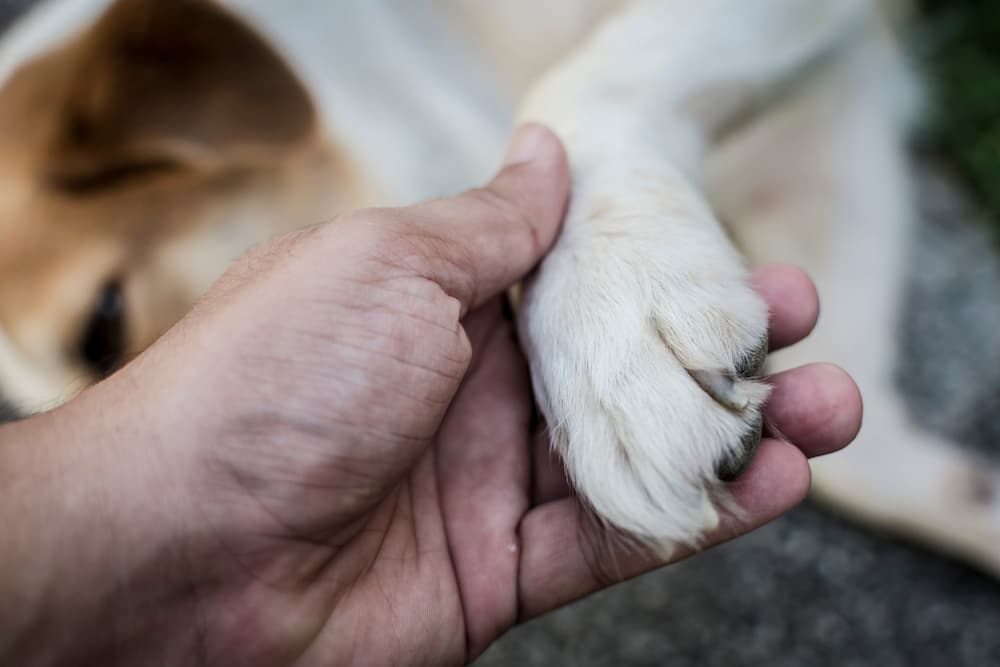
[[46, 0, 315, 189]]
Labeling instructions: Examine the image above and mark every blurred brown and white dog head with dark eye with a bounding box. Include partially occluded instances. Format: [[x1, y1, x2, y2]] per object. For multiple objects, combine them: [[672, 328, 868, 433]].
[[0, 0, 355, 412]]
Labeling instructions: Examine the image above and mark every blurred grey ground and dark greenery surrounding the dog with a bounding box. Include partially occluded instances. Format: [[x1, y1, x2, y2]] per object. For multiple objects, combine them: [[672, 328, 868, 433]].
[[0, 0, 1000, 667]]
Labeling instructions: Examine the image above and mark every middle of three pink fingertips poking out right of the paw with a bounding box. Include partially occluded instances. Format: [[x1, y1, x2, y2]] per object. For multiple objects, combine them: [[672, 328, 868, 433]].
[[767, 364, 863, 457]]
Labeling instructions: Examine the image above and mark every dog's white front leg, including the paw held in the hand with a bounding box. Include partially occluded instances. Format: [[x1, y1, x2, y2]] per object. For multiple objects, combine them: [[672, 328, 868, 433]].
[[519, 0, 865, 551]]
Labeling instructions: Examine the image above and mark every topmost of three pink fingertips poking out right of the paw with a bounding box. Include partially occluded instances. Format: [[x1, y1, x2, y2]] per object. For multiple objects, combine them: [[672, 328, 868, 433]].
[[752, 264, 819, 350]]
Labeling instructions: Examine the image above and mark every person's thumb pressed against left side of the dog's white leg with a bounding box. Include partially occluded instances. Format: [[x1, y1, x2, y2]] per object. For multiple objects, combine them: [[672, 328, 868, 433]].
[[399, 124, 570, 314]]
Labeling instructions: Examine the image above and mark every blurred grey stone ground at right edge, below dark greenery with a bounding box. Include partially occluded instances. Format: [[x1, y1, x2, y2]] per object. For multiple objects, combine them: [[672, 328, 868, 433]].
[[897, 170, 1000, 458]]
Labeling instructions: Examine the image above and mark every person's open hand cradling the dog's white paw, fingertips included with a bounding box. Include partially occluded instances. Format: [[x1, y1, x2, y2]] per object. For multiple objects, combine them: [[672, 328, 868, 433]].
[[0, 130, 860, 665]]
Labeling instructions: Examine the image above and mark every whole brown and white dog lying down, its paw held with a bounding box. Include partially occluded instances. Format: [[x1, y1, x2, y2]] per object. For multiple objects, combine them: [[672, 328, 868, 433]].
[[0, 0, 1000, 572]]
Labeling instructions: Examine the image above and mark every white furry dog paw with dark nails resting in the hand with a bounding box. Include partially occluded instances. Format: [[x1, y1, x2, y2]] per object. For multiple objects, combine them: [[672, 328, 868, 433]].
[[520, 184, 769, 552]]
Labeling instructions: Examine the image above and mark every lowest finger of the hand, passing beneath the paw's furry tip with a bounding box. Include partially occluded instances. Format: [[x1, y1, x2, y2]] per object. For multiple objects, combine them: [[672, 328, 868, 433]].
[[518, 439, 810, 621]]
